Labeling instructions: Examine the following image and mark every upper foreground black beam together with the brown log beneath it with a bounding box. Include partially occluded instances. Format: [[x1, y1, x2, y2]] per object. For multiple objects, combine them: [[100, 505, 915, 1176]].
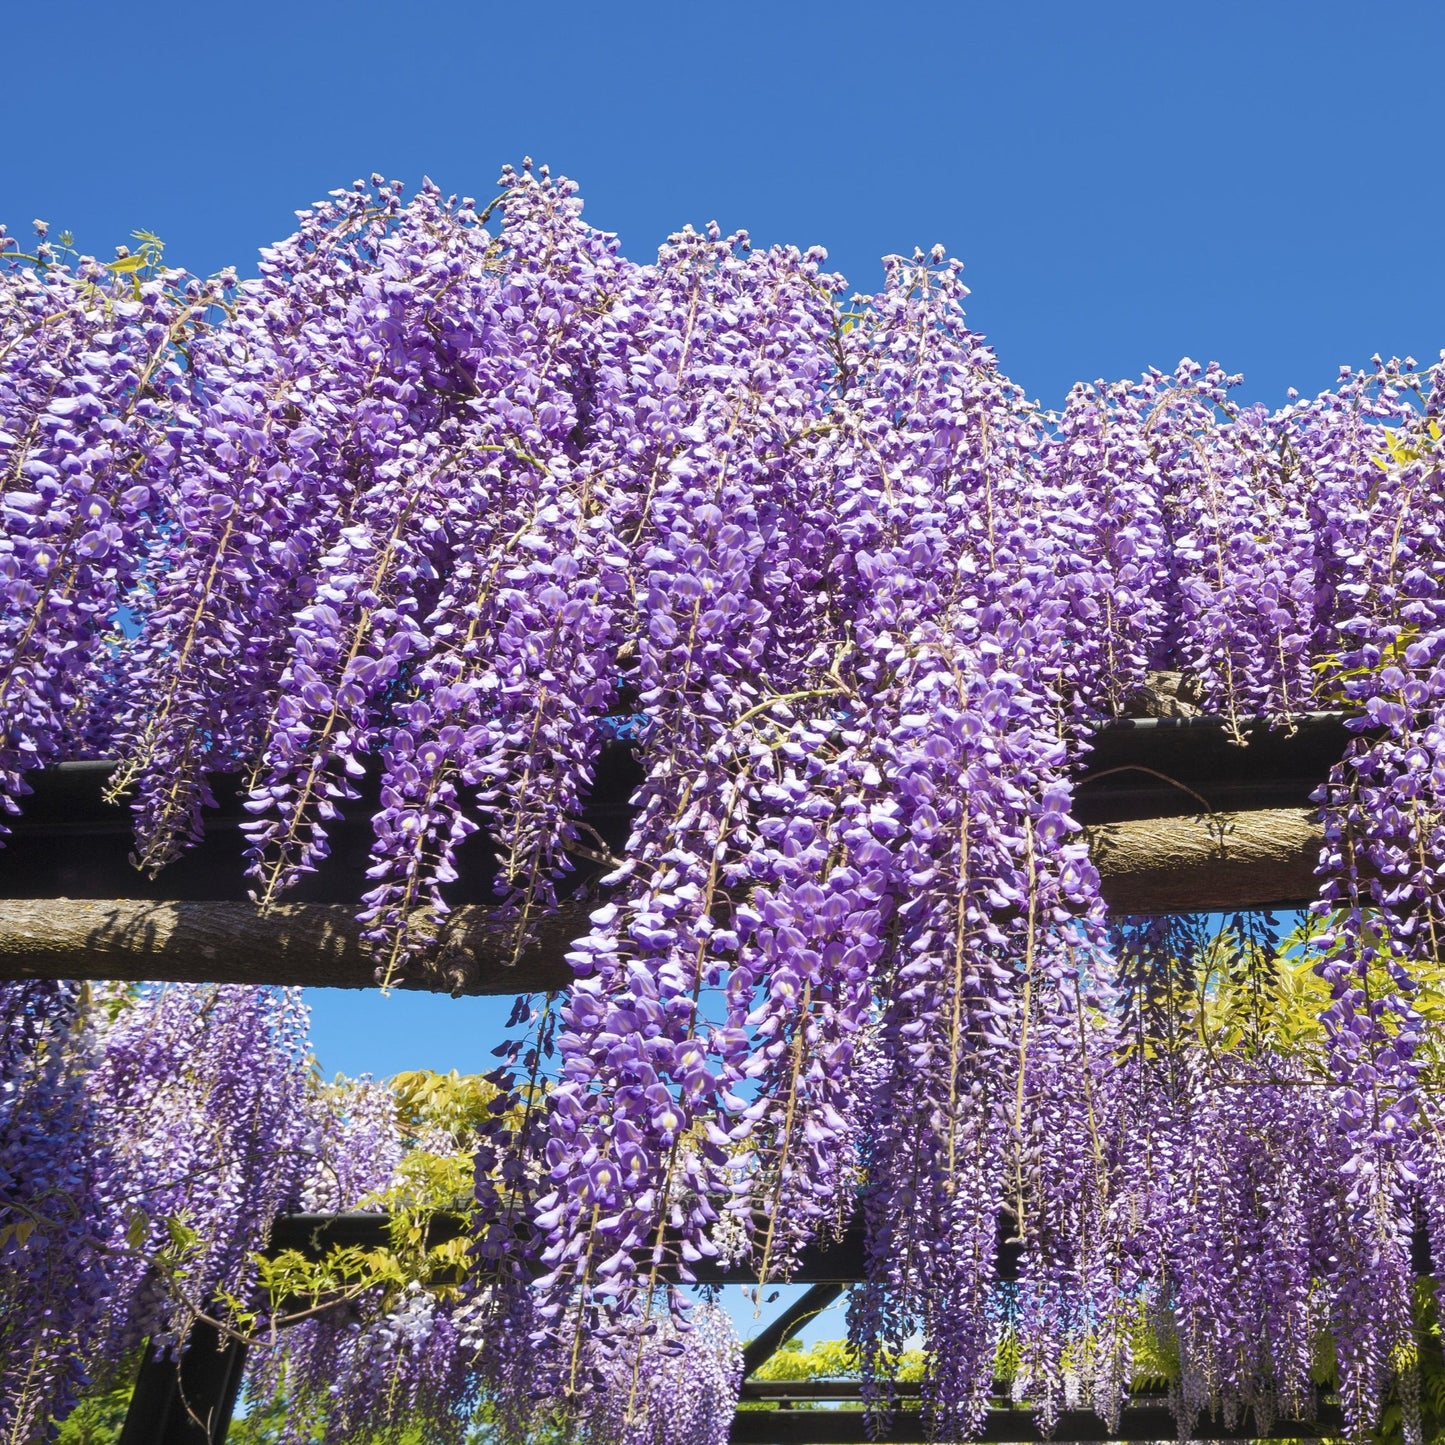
[[0, 714, 1348, 994]]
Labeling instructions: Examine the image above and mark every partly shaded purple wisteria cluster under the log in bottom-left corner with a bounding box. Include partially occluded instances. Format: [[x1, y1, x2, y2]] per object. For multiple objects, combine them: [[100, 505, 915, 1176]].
[[0, 983, 308, 1445]]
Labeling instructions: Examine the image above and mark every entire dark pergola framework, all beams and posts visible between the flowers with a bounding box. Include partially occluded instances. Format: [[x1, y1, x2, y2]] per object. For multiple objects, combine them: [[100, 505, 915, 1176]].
[[0, 714, 1369, 1445]]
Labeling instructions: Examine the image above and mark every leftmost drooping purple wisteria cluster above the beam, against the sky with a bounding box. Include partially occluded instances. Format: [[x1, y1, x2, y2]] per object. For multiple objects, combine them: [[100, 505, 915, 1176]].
[[0, 225, 224, 838]]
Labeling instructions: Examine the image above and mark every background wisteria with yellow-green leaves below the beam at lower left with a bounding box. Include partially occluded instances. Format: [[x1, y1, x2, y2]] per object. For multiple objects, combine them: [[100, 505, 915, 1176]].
[[0, 983, 738, 1445]]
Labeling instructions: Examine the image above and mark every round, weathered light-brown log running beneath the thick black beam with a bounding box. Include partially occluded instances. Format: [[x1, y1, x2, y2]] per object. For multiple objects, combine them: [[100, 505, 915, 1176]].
[[0, 808, 1321, 994]]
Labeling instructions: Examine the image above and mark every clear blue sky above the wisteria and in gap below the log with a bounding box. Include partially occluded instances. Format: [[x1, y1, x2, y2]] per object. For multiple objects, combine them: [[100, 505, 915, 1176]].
[[0, 0, 1445, 1074]]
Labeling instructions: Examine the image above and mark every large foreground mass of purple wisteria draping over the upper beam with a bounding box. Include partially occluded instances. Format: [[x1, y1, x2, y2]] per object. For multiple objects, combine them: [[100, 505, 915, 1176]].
[[0, 169, 1445, 1441]]
